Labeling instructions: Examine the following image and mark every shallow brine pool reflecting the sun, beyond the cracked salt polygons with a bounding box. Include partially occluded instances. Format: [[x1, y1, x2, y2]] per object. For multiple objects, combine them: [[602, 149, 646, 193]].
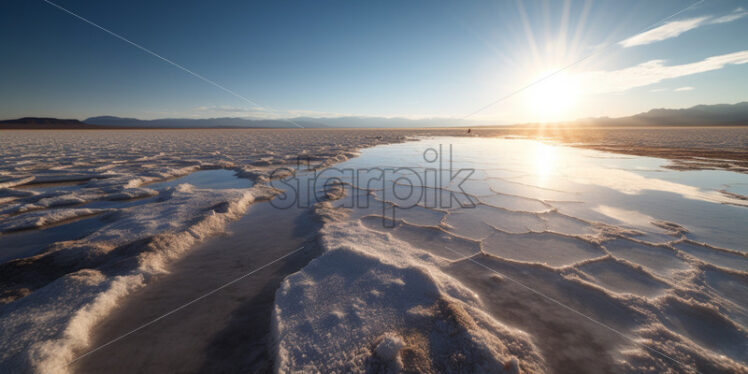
[[340, 138, 748, 252]]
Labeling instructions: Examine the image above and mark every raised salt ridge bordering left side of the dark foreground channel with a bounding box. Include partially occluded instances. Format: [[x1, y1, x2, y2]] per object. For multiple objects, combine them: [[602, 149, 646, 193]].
[[0, 185, 275, 373]]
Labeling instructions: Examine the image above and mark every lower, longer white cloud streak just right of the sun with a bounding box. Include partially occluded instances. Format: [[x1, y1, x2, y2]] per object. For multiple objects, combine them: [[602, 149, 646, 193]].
[[575, 50, 748, 94]]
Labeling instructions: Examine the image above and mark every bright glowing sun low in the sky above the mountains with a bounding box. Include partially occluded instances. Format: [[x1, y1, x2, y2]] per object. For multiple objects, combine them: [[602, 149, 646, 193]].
[[526, 69, 579, 122]]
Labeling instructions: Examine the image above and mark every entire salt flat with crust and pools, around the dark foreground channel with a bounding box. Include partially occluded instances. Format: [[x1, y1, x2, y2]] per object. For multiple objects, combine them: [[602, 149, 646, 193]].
[[0, 129, 748, 372]]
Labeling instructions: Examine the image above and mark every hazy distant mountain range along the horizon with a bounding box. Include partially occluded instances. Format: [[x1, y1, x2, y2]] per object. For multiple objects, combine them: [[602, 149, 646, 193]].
[[0, 102, 748, 129]]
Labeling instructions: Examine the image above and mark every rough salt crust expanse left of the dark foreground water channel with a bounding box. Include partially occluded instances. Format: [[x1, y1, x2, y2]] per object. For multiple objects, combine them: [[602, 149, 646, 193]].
[[0, 130, 414, 373]]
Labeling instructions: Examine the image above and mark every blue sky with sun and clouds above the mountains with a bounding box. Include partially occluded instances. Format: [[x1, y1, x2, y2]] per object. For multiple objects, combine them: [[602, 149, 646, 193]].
[[0, 0, 748, 123]]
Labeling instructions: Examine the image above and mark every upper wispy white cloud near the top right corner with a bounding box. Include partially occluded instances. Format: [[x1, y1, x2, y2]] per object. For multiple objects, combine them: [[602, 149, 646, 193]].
[[618, 8, 748, 48]]
